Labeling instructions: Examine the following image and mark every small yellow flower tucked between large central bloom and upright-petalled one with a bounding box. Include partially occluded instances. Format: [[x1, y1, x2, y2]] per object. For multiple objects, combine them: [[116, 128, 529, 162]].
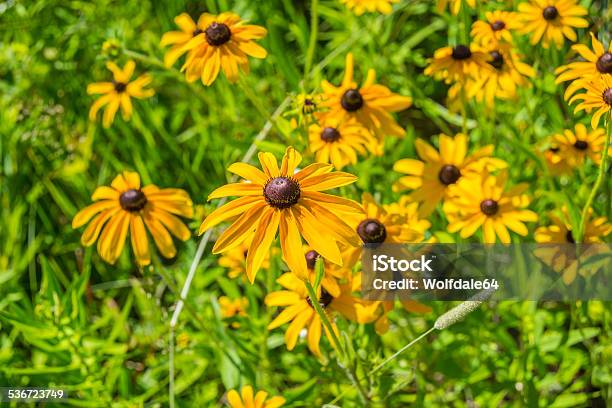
[[308, 117, 380, 170]]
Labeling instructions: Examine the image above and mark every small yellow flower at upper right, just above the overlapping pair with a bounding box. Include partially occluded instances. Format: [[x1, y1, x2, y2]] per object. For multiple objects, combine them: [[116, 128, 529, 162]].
[[471, 10, 519, 47]]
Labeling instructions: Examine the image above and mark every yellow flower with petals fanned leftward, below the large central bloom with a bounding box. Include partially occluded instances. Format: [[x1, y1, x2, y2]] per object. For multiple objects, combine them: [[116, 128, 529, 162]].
[[265, 273, 338, 356]]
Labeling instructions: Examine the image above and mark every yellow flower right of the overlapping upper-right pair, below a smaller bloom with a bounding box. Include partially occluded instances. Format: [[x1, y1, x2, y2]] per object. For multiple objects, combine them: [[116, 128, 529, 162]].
[[448, 44, 535, 107]]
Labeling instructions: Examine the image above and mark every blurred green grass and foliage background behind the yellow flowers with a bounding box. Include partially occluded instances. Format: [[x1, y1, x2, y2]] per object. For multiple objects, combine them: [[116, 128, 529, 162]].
[[0, 0, 612, 407]]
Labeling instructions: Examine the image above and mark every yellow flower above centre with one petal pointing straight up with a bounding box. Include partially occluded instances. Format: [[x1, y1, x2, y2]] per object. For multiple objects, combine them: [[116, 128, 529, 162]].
[[321, 53, 412, 140]]
